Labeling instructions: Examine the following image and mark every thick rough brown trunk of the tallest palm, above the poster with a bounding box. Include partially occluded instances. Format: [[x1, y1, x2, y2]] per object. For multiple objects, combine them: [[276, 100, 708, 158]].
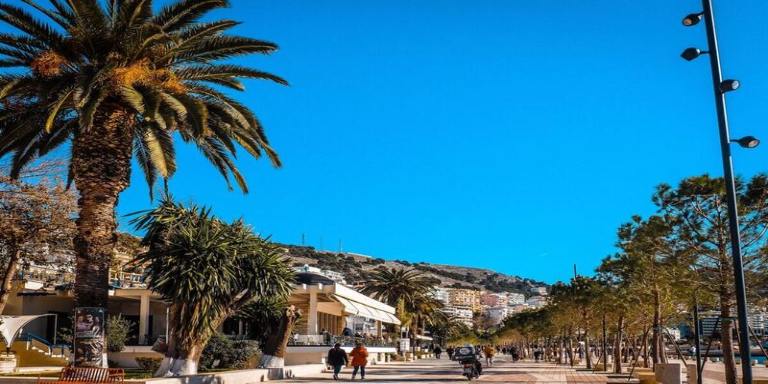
[[72, 103, 134, 308]]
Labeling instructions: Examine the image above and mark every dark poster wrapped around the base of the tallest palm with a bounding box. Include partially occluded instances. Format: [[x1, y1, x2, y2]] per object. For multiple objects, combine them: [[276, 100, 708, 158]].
[[74, 307, 106, 367]]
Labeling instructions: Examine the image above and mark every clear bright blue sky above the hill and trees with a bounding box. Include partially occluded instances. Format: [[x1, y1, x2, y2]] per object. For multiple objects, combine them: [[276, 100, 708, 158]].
[[15, 0, 768, 282]]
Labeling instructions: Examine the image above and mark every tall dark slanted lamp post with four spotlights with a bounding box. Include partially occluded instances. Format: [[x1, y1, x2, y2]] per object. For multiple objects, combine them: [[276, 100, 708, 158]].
[[681, 0, 759, 384]]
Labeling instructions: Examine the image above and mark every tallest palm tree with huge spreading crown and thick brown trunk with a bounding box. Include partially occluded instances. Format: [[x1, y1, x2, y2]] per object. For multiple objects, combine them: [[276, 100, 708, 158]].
[[0, 0, 286, 316]]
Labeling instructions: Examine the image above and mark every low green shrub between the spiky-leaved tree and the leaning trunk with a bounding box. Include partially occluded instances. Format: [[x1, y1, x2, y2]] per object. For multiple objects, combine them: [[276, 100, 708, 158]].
[[199, 333, 258, 371]]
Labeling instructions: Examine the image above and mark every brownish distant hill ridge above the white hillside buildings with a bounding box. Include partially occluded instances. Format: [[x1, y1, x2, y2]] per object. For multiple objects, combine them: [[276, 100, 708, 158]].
[[281, 244, 548, 297]]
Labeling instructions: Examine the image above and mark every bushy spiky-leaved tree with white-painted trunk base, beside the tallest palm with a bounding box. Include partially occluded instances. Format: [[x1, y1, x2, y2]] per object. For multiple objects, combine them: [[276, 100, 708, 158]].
[[133, 198, 294, 375]]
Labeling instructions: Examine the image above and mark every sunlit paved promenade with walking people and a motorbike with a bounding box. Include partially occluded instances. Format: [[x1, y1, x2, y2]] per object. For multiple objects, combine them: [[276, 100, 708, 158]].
[[283, 356, 606, 384]]
